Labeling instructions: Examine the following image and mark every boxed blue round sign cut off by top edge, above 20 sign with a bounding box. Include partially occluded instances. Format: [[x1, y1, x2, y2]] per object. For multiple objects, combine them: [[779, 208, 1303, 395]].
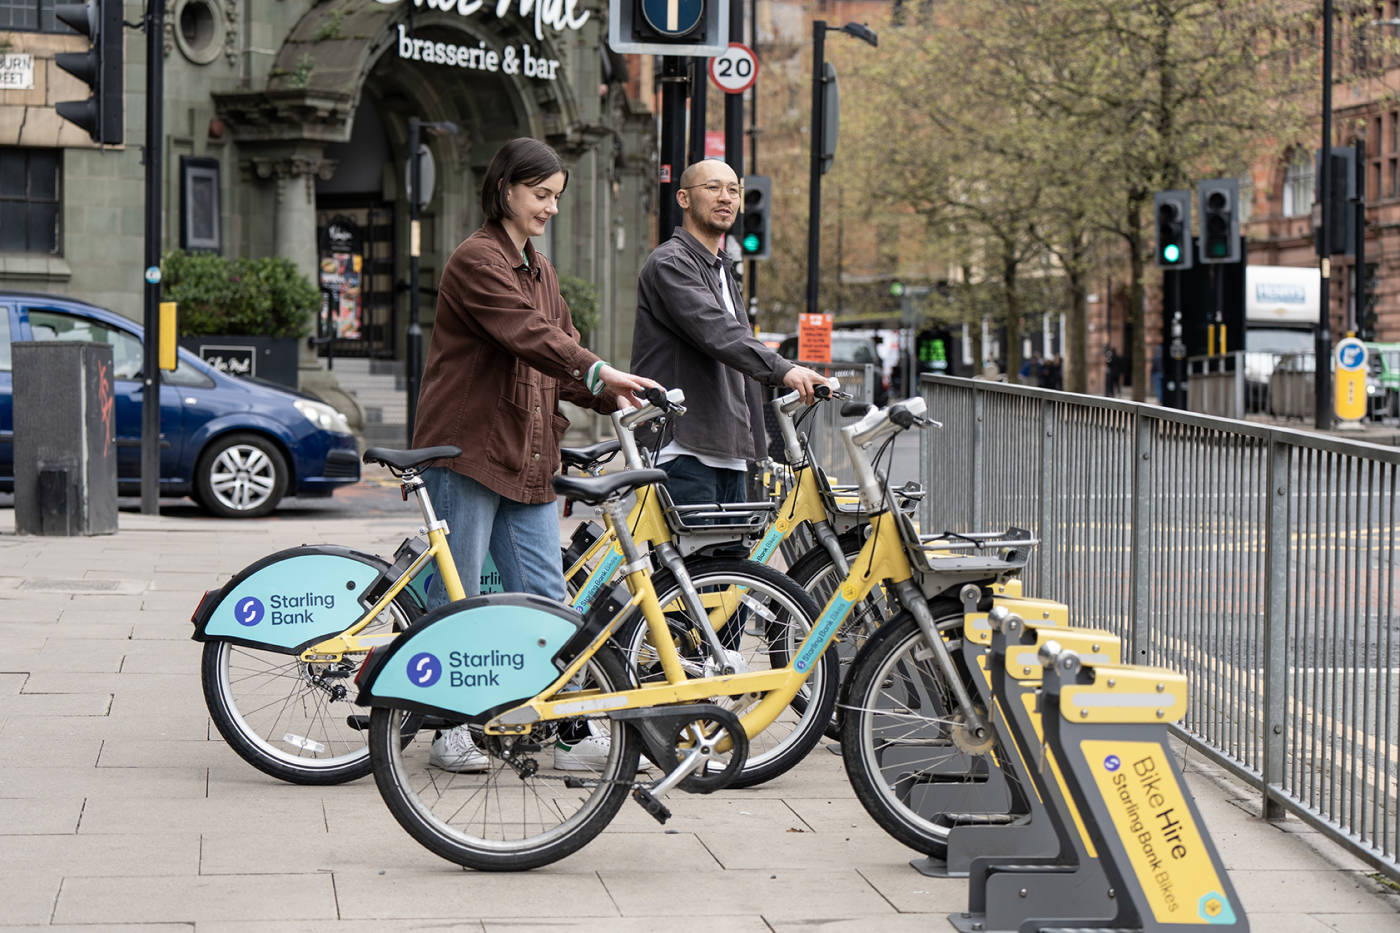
[[608, 0, 729, 57]]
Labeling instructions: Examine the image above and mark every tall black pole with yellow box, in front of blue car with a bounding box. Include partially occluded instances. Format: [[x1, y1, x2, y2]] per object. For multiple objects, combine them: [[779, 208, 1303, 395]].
[[141, 0, 165, 516]]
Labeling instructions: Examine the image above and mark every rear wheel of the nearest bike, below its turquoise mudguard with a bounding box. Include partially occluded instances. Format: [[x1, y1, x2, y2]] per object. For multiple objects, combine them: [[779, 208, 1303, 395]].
[[370, 646, 638, 871]]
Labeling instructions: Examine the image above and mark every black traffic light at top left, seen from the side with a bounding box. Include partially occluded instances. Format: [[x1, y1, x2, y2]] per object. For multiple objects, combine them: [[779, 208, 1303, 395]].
[[53, 0, 123, 146]]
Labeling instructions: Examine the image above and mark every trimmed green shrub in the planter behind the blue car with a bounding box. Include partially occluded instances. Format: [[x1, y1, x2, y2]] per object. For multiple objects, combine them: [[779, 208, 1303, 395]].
[[161, 249, 321, 338]]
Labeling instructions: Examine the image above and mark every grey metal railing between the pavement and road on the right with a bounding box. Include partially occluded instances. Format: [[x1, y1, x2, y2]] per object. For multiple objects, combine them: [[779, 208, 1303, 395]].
[[920, 377, 1400, 878]]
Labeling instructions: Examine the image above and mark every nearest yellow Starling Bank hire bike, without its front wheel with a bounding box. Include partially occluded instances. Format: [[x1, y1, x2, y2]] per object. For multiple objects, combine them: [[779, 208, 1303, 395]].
[[357, 398, 1030, 870]]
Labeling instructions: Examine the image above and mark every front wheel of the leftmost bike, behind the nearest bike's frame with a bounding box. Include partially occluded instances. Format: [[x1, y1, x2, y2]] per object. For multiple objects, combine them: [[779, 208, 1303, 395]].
[[616, 558, 839, 787]]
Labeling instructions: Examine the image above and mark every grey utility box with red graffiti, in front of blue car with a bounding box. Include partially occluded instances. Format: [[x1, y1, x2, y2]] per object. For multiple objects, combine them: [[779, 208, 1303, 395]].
[[11, 340, 116, 535]]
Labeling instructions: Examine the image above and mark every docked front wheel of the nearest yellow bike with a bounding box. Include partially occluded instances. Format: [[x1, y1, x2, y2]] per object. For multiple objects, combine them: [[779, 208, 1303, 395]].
[[841, 601, 1011, 859]]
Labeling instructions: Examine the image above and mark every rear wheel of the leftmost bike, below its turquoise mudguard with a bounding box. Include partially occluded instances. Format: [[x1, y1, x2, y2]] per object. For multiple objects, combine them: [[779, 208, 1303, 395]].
[[200, 591, 410, 785]]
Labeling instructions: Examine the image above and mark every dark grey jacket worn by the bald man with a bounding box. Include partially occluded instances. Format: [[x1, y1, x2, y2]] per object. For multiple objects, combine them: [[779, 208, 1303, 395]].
[[631, 227, 792, 459]]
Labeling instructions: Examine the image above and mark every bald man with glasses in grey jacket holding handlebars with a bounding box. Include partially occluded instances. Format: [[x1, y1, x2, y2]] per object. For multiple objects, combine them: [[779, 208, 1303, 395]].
[[631, 158, 826, 504]]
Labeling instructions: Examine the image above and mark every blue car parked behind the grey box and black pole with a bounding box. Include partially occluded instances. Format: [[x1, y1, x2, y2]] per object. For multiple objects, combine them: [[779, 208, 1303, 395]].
[[0, 291, 360, 518]]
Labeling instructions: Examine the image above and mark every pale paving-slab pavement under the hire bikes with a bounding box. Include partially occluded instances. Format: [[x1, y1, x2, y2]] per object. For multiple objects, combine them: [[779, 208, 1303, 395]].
[[0, 483, 1400, 933]]
